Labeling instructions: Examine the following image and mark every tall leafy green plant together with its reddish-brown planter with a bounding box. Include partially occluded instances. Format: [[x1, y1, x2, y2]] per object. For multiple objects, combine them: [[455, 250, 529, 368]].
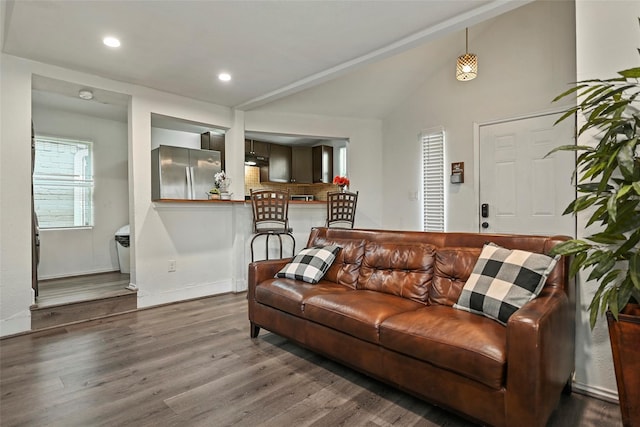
[[549, 61, 640, 426]]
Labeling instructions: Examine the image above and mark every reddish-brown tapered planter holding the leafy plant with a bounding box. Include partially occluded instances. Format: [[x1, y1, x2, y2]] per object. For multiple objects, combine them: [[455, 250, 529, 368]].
[[607, 304, 640, 427]]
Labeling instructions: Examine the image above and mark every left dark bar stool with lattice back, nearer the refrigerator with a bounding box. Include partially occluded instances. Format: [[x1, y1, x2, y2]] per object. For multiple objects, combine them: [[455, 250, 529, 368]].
[[250, 190, 296, 262]]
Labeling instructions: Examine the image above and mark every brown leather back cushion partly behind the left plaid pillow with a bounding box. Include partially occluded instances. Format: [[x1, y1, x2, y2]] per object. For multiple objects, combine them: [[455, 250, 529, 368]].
[[310, 237, 365, 289]]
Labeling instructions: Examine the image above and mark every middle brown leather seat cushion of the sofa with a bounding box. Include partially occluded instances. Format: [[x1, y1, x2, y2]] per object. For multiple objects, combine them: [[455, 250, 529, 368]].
[[303, 290, 424, 344]]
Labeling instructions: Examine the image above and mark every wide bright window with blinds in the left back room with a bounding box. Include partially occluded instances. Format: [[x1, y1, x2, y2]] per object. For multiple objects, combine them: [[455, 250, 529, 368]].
[[33, 137, 94, 228]]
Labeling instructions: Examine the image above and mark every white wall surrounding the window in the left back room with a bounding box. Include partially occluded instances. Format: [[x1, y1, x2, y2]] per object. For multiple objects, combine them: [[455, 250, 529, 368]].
[[33, 106, 129, 279]]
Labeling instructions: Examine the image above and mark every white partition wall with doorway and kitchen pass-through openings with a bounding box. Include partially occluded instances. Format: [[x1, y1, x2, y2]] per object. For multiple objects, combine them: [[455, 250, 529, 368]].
[[0, 54, 382, 336]]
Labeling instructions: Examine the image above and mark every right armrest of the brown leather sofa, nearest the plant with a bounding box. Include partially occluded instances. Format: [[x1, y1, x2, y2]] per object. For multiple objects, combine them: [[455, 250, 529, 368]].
[[505, 288, 575, 426]]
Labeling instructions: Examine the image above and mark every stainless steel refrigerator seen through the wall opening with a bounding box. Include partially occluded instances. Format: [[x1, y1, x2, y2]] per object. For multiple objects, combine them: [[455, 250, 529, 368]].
[[151, 145, 221, 200]]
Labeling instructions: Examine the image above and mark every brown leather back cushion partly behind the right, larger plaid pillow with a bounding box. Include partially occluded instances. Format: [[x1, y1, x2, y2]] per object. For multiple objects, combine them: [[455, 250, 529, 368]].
[[429, 247, 482, 307]]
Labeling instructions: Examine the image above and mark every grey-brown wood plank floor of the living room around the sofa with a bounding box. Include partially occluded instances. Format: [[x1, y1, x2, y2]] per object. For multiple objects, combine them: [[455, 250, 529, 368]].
[[0, 294, 622, 427]]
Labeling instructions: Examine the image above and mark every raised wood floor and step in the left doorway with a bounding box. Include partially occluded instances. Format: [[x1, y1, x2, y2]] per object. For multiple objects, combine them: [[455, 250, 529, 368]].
[[31, 271, 138, 330]]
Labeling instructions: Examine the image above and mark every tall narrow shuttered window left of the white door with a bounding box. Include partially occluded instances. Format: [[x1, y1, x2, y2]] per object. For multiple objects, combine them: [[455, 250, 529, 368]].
[[420, 128, 445, 231]]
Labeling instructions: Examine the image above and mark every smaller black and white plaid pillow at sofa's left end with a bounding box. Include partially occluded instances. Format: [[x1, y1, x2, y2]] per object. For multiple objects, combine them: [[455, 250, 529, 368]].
[[275, 246, 340, 284]]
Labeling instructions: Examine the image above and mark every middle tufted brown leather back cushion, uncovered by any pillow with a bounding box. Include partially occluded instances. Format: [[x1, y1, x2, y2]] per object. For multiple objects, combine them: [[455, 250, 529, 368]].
[[358, 242, 435, 303]]
